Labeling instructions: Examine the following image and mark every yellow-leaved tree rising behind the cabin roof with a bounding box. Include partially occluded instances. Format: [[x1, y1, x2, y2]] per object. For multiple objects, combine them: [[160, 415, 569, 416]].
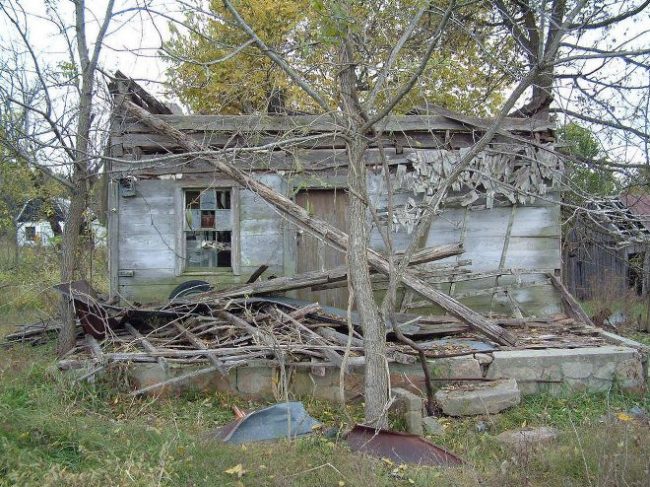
[[165, 0, 516, 115]]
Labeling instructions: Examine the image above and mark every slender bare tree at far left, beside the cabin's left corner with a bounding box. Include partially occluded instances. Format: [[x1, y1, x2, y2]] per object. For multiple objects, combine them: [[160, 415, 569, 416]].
[[0, 0, 115, 355]]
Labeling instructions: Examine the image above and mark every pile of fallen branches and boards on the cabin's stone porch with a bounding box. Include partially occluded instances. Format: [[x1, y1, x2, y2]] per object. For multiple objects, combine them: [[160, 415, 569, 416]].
[[0, 270, 604, 393]]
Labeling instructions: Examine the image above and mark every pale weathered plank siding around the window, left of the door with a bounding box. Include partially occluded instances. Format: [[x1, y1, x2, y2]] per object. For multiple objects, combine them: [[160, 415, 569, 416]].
[[111, 174, 286, 302]]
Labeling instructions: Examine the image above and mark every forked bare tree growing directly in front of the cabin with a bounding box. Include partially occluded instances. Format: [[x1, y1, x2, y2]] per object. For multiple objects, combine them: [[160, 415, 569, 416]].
[[148, 0, 647, 424]]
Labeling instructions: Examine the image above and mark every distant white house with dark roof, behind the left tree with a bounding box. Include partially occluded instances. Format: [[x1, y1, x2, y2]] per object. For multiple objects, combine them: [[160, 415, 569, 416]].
[[16, 198, 106, 247]]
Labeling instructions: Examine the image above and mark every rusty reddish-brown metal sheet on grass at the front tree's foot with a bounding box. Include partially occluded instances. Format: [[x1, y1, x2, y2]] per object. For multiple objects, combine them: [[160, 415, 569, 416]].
[[345, 425, 464, 467]]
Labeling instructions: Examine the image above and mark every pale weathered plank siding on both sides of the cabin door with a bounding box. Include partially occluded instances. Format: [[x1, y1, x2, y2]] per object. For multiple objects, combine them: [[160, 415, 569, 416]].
[[112, 170, 561, 315]]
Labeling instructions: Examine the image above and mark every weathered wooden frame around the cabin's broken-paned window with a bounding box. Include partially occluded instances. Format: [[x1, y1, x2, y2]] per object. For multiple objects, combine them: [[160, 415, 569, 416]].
[[175, 180, 241, 276]]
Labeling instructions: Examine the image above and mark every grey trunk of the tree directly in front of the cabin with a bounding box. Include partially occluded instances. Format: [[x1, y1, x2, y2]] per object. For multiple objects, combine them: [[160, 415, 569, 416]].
[[347, 138, 389, 427]]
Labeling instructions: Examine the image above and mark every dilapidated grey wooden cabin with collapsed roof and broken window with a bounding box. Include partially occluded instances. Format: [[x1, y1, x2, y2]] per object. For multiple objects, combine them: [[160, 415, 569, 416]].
[[108, 76, 562, 317]]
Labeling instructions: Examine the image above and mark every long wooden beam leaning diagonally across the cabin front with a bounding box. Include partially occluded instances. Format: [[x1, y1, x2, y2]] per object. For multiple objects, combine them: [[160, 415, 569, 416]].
[[123, 100, 517, 346]]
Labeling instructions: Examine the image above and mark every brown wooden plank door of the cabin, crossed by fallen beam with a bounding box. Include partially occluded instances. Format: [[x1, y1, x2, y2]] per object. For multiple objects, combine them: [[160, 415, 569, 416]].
[[296, 189, 348, 309]]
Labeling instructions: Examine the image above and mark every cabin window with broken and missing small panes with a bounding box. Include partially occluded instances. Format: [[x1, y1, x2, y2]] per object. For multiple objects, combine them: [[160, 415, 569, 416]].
[[185, 188, 233, 268]]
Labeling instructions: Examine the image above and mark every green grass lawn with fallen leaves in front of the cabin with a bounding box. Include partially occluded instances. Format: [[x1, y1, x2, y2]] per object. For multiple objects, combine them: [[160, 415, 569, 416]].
[[0, 316, 650, 486]]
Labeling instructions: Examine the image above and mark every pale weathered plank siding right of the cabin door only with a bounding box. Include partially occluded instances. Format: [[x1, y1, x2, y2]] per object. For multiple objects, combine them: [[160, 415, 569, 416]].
[[369, 179, 562, 316]]
